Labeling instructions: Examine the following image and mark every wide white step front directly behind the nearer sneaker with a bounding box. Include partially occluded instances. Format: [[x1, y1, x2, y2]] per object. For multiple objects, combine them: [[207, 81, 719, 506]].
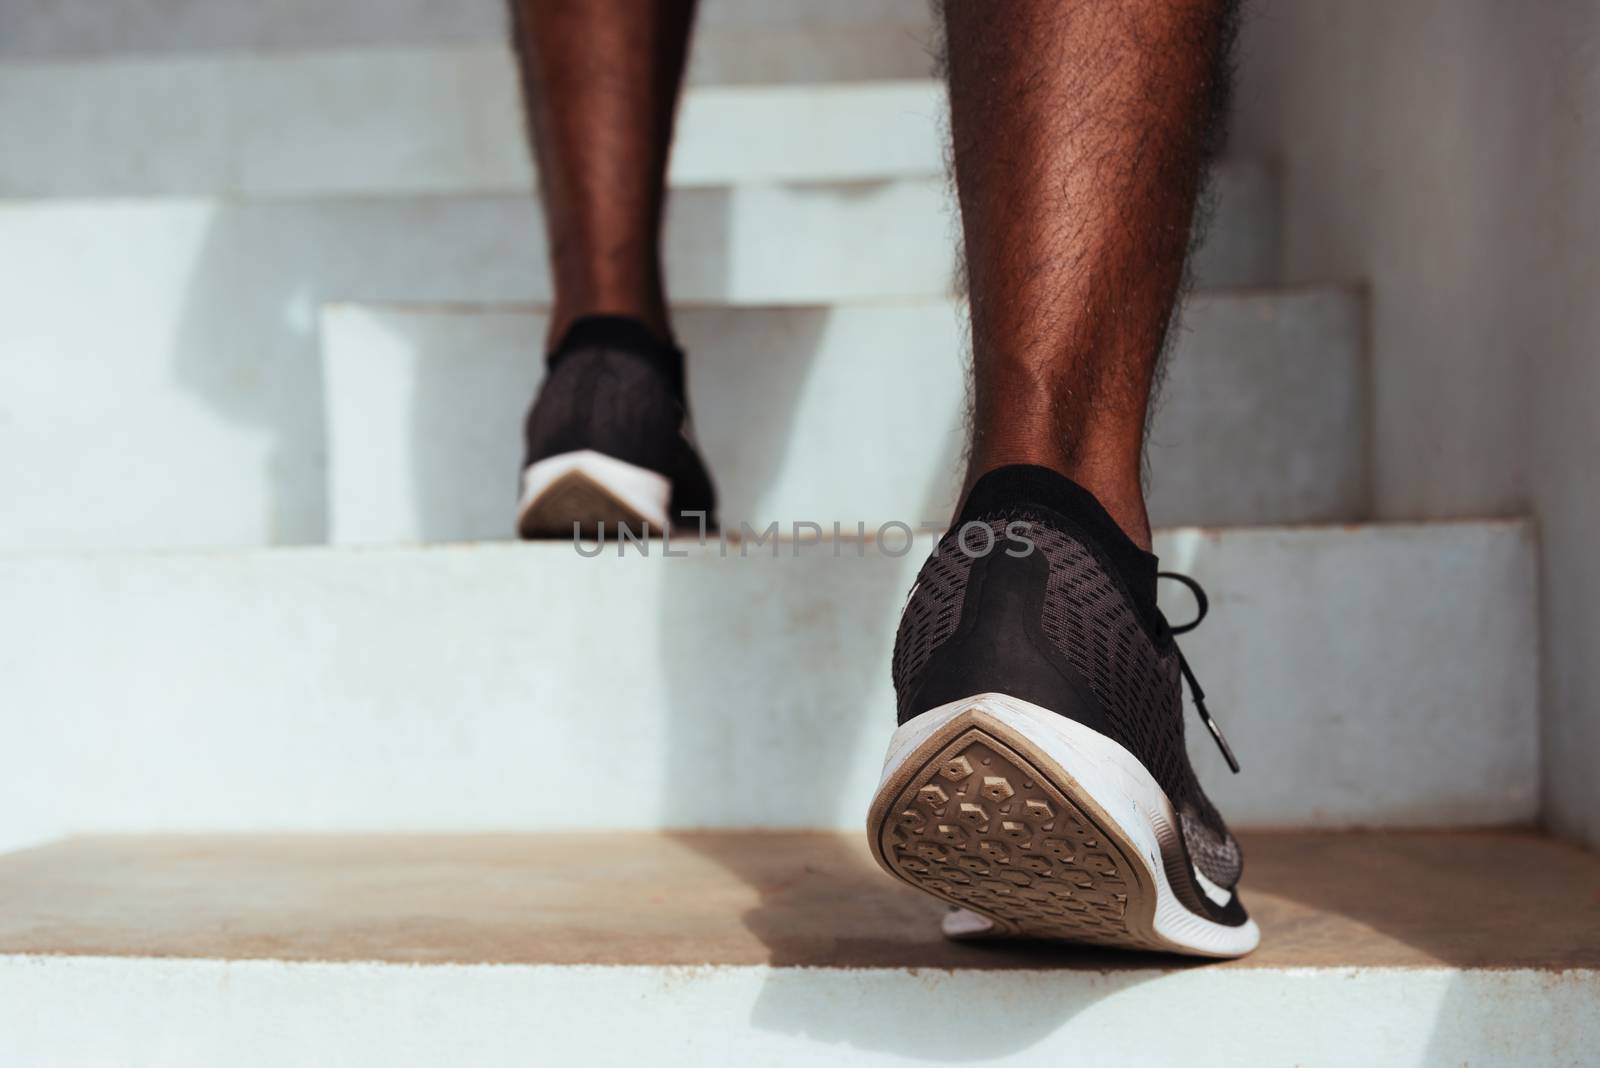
[[0, 521, 1539, 847]]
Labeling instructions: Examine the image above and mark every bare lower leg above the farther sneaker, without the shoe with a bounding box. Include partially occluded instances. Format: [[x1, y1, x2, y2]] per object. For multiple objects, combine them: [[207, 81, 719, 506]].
[[510, 0, 694, 342]]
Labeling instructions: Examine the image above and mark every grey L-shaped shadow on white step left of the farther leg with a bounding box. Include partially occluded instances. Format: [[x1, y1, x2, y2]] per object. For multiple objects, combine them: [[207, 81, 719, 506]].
[[171, 197, 563, 544]]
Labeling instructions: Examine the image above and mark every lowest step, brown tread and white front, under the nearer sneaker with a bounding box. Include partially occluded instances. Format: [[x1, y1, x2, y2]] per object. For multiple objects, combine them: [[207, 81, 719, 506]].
[[0, 831, 1600, 1068]]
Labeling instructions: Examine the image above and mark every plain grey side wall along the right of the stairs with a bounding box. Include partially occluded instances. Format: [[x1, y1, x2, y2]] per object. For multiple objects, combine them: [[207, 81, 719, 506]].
[[1235, 0, 1600, 846]]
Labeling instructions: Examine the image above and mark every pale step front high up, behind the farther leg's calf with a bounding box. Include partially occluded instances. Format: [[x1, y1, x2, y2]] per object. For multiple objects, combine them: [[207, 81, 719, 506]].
[[0, 56, 944, 197]]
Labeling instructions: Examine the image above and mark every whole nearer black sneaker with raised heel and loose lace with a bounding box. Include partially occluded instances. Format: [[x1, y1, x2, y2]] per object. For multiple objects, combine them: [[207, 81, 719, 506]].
[[867, 465, 1261, 956]]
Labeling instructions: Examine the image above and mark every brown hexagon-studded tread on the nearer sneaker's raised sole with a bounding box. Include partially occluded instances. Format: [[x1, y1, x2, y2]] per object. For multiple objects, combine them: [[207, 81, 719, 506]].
[[878, 727, 1166, 950]]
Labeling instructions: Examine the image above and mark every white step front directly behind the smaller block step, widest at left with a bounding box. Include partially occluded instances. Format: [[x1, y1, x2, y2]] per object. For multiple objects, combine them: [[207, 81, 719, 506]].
[[0, 167, 1275, 548]]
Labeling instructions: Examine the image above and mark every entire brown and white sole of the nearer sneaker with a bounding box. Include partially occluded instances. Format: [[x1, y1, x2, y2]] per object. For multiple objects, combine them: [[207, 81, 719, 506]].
[[867, 692, 1261, 958]]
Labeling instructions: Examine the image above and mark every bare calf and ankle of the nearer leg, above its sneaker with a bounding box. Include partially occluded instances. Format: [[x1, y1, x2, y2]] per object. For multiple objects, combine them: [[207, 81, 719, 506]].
[[944, 0, 1230, 548]]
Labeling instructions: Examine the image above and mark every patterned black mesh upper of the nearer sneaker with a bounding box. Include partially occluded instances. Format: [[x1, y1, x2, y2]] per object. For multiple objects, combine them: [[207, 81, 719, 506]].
[[891, 508, 1243, 887]]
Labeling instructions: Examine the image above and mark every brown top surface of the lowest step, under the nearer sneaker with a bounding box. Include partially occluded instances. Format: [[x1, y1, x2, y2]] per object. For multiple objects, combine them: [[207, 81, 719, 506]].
[[0, 831, 1600, 970]]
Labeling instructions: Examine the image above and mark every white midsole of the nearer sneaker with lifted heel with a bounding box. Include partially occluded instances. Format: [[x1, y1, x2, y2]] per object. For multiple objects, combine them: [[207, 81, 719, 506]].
[[878, 694, 1261, 956]]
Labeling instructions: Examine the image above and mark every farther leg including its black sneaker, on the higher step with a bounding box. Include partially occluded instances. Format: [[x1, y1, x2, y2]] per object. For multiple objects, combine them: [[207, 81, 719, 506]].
[[510, 0, 715, 537]]
